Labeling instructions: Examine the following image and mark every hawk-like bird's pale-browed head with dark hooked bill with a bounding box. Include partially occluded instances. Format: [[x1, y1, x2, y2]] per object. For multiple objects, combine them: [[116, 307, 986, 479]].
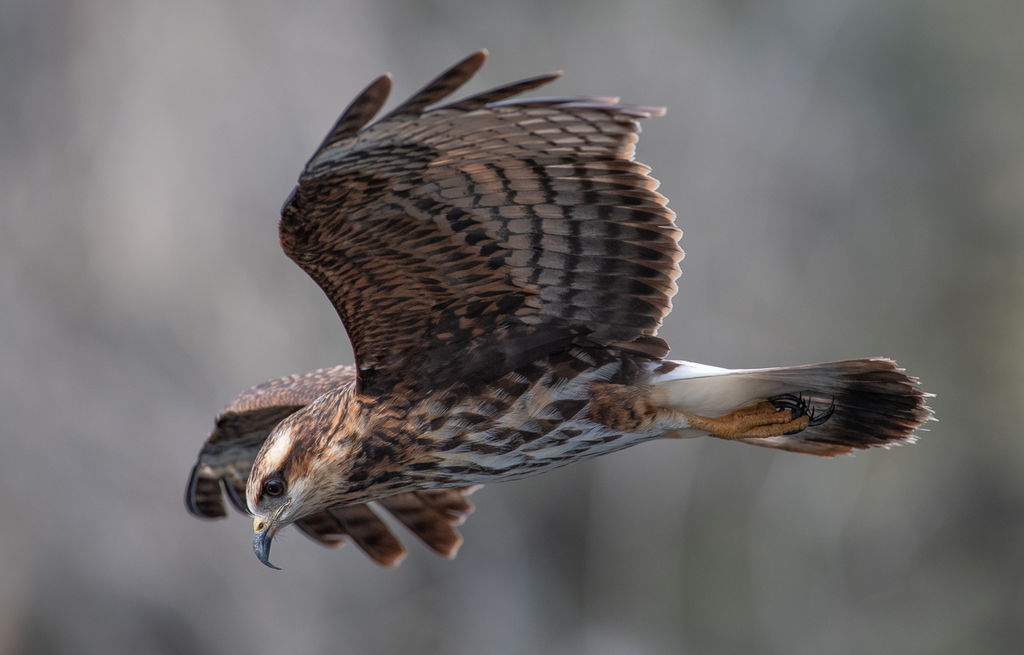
[[246, 394, 356, 569]]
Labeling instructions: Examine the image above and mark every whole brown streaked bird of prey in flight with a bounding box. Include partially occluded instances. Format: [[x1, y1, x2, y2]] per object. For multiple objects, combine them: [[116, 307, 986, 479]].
[[186, 51, 931, 568]]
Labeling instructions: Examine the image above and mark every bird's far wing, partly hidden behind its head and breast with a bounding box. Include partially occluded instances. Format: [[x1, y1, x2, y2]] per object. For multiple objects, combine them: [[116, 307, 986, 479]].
[[185, 366, 473, 566]]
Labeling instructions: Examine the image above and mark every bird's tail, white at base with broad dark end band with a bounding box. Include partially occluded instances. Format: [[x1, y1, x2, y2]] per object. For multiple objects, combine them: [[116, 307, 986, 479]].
[[648, 357, 932, 456]]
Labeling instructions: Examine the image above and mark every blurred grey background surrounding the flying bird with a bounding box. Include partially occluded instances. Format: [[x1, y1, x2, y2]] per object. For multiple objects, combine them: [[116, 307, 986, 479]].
[[0, 0, 1024, 655]]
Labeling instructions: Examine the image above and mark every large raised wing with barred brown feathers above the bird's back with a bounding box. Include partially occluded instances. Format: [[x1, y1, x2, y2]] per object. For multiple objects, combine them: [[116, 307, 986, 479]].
[[281, 51, 683, 394]]
